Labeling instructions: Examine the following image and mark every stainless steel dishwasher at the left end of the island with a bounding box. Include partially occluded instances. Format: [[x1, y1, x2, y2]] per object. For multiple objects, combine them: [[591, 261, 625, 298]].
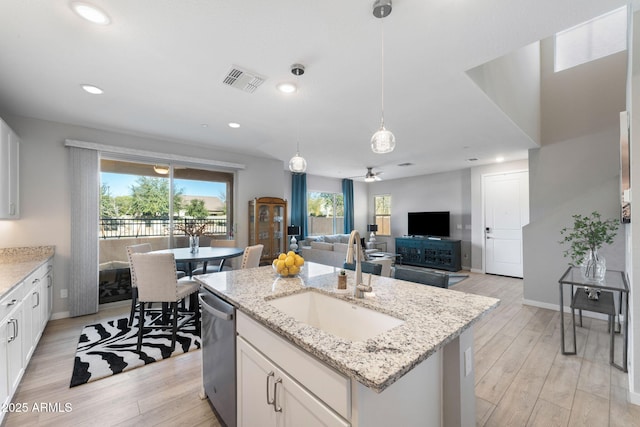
[[198, 289, 236, 427]]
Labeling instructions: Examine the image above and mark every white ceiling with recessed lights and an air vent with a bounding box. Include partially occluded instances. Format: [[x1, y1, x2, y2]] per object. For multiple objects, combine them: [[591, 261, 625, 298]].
[[0, 0, 625, 179]]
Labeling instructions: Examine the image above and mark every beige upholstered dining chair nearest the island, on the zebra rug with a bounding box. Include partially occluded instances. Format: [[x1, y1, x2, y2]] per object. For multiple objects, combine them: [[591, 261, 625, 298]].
[[131, 253, 200, 353]]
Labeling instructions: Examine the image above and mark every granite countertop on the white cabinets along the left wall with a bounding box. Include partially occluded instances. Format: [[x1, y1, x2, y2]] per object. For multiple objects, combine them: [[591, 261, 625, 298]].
[[0, 246, 55, 299]]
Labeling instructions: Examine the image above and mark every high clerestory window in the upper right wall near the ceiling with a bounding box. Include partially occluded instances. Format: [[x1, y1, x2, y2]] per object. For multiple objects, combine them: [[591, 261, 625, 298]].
[[554, 6, 627, 72]]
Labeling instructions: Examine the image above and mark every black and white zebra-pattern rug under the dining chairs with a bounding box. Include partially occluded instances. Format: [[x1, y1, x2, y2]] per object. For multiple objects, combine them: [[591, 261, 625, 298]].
[[69, 315, 200, 387]]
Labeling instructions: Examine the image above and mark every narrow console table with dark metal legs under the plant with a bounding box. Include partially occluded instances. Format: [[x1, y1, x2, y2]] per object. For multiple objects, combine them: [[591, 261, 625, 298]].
[[558, 267, 629, 372]]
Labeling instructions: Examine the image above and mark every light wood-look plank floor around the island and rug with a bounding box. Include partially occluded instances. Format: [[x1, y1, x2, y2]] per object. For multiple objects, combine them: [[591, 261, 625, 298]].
[[3, 273, 640, 427]]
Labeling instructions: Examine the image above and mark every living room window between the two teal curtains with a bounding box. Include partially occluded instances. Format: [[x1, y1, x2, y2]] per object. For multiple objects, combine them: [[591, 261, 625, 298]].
[[307, 191, 344, 236]]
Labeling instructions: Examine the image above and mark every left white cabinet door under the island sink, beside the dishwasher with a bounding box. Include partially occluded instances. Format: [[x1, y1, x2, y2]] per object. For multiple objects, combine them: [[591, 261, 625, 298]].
[[237, 337, 276, 427]]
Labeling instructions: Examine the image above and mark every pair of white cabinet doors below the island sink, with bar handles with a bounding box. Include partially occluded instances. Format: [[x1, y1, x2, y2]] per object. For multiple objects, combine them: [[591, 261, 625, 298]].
[[237, 337, 349, 427]]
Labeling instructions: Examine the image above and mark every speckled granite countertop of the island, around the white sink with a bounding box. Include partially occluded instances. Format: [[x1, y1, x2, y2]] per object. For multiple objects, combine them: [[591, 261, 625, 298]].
[[195, 262, 500, 392]]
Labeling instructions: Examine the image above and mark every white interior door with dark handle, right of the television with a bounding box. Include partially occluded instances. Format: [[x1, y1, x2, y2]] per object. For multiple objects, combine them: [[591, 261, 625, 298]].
[[483, 171, 529, 277]]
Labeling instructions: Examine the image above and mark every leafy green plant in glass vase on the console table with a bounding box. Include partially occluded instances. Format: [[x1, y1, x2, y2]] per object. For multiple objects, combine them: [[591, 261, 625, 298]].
[[560, 212, 618, 290]]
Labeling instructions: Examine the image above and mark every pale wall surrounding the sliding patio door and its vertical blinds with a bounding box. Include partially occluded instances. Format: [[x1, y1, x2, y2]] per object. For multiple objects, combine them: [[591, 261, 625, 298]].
[[0, 114, 285, 316]]
